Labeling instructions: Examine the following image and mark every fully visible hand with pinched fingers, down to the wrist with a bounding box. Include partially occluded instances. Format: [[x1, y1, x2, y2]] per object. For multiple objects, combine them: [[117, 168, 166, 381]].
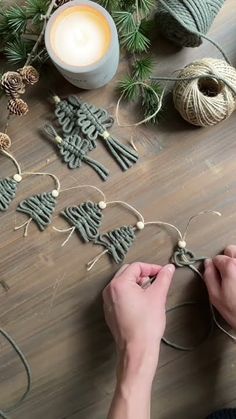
[[103, 263, 175, 382]]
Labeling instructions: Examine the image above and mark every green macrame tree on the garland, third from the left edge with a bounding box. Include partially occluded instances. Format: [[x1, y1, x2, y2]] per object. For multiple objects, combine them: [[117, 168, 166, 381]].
[[61, 201, 103, 243]]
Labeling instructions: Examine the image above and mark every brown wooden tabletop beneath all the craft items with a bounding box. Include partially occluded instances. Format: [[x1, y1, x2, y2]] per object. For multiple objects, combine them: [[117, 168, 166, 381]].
[[0, 0, 236, 419]]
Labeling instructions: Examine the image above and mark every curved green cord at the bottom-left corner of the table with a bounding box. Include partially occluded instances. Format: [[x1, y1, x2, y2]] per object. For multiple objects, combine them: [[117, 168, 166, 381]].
[[0, 328, 32, 419]]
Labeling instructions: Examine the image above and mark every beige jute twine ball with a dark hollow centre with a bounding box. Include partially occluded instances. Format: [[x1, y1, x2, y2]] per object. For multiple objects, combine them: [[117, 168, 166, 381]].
[[173, 58, 236, 127]]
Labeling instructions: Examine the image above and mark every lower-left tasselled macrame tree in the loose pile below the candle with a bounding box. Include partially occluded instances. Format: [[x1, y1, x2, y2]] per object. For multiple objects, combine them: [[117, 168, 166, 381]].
[[45, 124, 109, 180]]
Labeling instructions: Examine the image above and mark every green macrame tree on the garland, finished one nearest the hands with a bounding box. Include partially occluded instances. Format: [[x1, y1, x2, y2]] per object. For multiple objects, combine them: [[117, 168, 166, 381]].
[[94, 226, 136, 263]]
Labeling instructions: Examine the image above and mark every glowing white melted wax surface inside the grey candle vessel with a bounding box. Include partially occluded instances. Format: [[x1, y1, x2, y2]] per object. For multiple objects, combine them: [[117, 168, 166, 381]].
[[51, 6, 111, 66]]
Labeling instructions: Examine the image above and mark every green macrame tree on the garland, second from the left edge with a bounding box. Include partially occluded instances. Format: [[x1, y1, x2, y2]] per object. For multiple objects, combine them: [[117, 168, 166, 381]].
[[17, 192, 57, 231]]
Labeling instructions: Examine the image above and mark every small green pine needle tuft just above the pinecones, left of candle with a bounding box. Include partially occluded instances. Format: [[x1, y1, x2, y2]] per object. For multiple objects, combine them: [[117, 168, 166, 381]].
[[5, 38, 34, 65]]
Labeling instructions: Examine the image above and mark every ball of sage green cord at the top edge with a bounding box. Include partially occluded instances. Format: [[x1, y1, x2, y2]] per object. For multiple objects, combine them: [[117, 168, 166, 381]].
[[157, 0, 225, 47]]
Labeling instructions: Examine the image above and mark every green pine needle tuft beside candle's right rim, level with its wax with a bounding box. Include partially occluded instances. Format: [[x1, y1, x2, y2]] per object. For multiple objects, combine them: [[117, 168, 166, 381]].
[[121, 29, 150, 53]]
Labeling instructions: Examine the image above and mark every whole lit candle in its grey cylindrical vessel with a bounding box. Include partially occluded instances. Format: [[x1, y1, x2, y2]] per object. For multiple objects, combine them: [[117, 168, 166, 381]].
[[45, 0, 119, 89]]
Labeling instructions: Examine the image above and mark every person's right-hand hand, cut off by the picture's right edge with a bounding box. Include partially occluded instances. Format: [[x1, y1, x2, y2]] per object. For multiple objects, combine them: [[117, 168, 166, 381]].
[[204, 245, 236, 330]]
